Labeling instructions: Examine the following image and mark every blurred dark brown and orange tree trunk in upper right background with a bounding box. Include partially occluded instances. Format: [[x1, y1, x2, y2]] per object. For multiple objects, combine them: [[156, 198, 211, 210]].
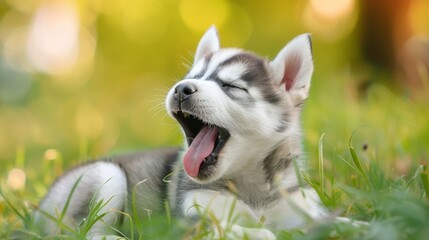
[[360, 0, 429, 95]]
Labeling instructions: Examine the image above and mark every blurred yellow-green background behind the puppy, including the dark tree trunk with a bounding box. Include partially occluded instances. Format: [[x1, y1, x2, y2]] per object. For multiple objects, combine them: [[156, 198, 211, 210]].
[[0, 0, 429, 207]]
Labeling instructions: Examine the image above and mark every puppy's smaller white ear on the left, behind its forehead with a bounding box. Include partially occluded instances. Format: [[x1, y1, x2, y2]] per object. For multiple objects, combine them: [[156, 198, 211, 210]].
[[194, 26, 220, 64]]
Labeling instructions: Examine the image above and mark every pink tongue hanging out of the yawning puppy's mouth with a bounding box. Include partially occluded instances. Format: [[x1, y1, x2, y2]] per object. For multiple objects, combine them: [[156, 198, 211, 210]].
[[183, 126, 219, 177]]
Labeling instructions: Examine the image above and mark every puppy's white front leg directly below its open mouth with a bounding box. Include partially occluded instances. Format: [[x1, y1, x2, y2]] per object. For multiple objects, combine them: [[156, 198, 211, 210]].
[[182, 190, 276, 239]]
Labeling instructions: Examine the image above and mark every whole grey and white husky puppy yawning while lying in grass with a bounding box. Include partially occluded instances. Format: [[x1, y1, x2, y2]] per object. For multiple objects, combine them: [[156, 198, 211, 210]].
[[35, 27, 326, 239]]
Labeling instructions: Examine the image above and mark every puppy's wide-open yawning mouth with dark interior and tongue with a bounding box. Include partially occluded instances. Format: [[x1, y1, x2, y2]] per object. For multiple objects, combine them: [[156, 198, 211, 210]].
[[173, 111, 230, 177]]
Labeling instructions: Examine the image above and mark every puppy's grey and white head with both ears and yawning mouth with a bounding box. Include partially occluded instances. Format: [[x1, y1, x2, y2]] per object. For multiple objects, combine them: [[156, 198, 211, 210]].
[[166, 27, 313, 183]]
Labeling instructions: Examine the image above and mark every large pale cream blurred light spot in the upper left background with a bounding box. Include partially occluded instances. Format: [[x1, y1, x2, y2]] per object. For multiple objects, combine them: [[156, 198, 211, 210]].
[[27, 0, 79, 74]]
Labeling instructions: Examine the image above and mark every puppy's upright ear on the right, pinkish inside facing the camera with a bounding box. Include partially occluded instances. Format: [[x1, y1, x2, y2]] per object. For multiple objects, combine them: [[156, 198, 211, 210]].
[[270, 33, 313, 101]]
